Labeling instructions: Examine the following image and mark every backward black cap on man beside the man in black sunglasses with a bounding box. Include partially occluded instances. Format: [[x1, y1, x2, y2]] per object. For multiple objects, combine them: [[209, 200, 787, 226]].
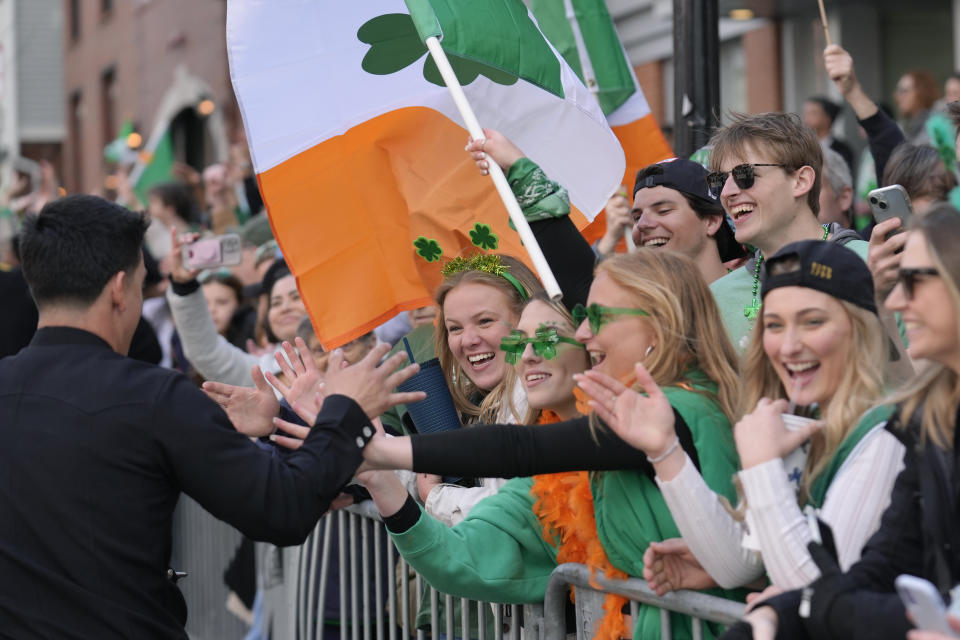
[[633, 158, 745, 262]]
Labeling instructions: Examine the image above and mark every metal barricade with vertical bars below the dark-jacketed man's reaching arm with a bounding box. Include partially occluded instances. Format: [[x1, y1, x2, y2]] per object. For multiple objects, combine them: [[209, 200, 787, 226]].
[[278, 501, 528, 640]]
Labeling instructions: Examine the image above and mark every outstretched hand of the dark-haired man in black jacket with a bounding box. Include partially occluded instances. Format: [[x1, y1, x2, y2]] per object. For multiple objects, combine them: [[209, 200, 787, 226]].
[[318, 344, 427, 424]]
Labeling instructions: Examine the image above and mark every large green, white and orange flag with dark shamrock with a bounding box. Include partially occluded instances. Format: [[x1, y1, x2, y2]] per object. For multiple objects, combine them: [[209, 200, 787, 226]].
[[227, 0, 624, 347]]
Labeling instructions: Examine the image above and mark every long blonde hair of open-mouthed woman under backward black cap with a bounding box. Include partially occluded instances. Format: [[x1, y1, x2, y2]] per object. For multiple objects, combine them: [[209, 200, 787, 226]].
[[740, 298, 888, 504]]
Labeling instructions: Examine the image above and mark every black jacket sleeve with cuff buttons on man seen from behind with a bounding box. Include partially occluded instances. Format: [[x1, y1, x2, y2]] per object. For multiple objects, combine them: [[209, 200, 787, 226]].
[[153, 376, 374, 546]]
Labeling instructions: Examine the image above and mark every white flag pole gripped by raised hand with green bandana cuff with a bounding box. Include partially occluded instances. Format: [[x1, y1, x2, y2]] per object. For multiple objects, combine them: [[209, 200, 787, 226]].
[[426, 36, 562, 300]]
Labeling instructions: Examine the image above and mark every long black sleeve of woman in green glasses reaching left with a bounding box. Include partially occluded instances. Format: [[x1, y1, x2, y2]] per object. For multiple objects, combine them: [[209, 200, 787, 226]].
[[411, 411, 699, 478]]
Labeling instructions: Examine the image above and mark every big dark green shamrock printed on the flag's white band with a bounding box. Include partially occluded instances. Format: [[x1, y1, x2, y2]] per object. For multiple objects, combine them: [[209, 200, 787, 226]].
[[357, 13, 517, 87]]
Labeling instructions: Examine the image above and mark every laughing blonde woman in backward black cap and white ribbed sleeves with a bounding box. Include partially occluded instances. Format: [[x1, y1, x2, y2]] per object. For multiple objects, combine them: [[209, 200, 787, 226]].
[[632, 240, 904, 590]]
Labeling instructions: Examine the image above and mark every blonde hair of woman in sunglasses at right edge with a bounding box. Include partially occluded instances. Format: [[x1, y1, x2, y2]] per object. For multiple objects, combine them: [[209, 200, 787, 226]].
[[891, 203, 960, 450]]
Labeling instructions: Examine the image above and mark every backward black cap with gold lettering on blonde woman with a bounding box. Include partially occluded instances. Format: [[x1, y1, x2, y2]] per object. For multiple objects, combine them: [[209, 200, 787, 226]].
[[760, 240, 877, 313]]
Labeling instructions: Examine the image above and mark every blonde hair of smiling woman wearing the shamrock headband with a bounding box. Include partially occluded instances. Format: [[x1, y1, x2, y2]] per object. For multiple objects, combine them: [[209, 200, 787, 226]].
[[434, 255, 543, 422]]
